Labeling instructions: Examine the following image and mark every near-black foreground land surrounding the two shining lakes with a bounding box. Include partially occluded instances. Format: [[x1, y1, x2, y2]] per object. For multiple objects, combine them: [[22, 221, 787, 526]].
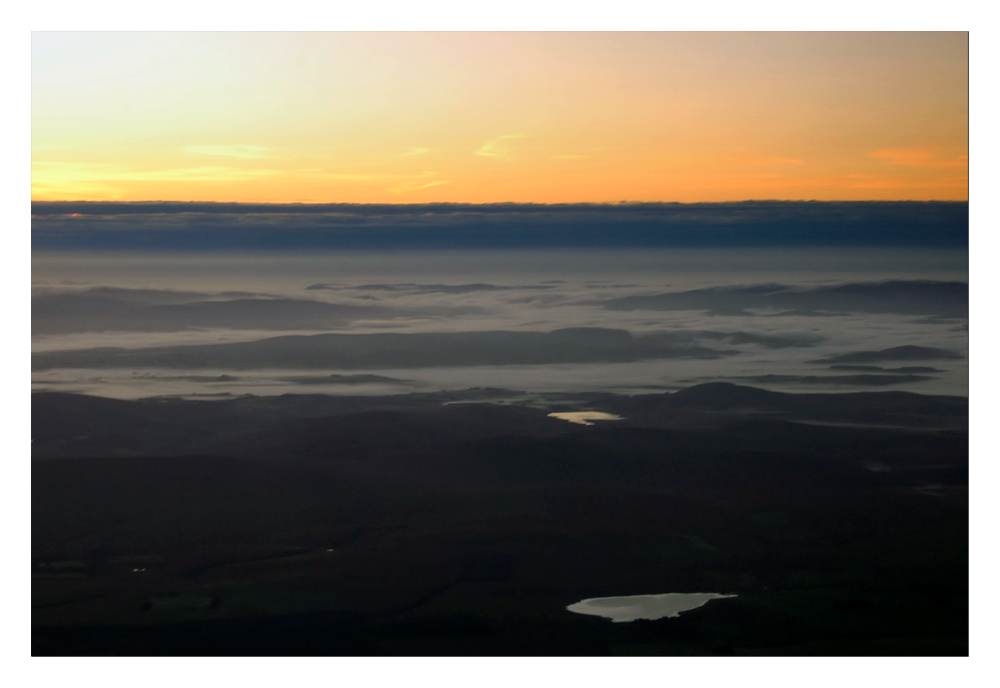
[[32, 384, 969, 655]]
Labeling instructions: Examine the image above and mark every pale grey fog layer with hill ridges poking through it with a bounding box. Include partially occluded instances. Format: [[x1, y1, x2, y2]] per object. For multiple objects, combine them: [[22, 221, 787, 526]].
[[32, 248, 968, 398]]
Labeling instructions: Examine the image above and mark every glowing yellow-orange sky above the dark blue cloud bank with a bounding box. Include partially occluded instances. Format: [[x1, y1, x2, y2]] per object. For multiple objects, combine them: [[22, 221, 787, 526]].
[[31, 32, 968, 203]]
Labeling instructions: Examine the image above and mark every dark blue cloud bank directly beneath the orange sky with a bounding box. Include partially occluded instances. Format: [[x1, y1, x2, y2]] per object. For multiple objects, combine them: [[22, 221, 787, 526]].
[[32, 201, 968, 251]]
